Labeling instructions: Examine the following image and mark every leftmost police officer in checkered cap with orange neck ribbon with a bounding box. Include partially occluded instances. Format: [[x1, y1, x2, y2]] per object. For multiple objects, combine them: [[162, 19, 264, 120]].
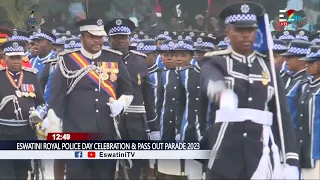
[[0, 41, 45, 179]]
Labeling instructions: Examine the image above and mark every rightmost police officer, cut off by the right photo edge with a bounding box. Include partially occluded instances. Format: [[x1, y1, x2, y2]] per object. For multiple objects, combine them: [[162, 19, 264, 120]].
[[295, 46, 320, 179]]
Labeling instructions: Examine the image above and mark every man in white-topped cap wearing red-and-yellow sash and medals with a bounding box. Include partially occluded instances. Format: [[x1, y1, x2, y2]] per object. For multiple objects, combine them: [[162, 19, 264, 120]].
[[43, 19, 133, 179]]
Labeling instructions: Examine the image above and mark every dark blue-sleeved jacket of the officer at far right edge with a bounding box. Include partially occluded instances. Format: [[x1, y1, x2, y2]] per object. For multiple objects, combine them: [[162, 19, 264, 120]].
[[295, 79, 320, 168]]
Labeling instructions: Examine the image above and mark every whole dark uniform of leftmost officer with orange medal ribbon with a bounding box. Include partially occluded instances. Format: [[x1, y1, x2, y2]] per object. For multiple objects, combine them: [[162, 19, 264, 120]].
[[0, 68, 45, 180]]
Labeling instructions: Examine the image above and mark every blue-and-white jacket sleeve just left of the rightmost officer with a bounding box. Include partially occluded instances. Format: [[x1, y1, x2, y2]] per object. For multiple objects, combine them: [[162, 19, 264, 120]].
[[286, 69, 308, 127]]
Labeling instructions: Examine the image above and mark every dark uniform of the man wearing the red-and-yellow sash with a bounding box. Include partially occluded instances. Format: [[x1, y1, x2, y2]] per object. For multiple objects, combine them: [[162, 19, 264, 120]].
[[49, 49, 132, 180]]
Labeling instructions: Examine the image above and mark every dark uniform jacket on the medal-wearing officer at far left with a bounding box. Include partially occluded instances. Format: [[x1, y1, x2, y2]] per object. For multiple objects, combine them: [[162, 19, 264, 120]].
[[0, 68, 45, 140]]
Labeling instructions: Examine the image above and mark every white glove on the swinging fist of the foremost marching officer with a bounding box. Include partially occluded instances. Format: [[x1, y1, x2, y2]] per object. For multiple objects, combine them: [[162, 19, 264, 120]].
[[220, 89, 239, 109]]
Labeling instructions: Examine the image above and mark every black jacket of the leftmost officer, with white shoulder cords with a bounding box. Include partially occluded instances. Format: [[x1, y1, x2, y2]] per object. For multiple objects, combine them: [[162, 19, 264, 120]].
[[0, 68, 45, 136]]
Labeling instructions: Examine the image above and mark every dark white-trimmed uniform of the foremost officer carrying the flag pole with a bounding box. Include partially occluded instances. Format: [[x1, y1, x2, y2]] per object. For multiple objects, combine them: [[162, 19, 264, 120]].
[[200, 50, 299, 177]]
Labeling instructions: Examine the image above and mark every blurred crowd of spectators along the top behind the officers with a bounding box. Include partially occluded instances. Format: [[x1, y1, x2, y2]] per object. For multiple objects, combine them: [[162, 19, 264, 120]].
[[0, 0, 320, 35]]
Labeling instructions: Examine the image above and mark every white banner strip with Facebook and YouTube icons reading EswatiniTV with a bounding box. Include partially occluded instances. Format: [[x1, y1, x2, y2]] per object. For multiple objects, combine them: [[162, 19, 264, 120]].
[[0, 150, 211, 160]]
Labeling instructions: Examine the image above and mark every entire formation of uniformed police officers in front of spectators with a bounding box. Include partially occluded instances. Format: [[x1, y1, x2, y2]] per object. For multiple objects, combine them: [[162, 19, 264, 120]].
[[0, 2, 320, 179]]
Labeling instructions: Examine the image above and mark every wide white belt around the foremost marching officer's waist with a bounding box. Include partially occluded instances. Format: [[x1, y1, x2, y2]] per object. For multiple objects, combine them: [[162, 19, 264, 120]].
[[215, 108, 273, 126]]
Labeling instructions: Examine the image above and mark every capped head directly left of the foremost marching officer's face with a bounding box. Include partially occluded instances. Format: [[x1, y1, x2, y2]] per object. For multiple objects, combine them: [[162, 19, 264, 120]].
[[192, 36, 215, 61]]
